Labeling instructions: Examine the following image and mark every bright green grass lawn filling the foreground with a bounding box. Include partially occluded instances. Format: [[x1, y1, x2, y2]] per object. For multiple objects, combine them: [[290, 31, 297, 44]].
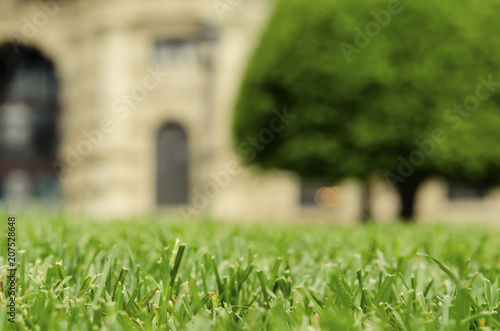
[[0, 215, 500, 330]]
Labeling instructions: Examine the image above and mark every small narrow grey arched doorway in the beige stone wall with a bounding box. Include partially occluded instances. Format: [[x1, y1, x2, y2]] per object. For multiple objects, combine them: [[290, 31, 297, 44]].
[[157, 123, 189, 206]]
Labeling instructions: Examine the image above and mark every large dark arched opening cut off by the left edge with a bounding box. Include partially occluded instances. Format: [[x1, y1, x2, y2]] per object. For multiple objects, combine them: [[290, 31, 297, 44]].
[[0, 44, 60, 205]]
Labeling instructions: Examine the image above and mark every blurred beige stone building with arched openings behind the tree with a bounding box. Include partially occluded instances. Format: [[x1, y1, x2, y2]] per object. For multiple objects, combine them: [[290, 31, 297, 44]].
[[0, 0, 499, 221]]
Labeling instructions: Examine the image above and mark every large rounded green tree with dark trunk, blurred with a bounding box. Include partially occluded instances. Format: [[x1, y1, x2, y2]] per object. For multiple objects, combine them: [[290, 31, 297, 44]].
[[234, 0, 500, 219]]
